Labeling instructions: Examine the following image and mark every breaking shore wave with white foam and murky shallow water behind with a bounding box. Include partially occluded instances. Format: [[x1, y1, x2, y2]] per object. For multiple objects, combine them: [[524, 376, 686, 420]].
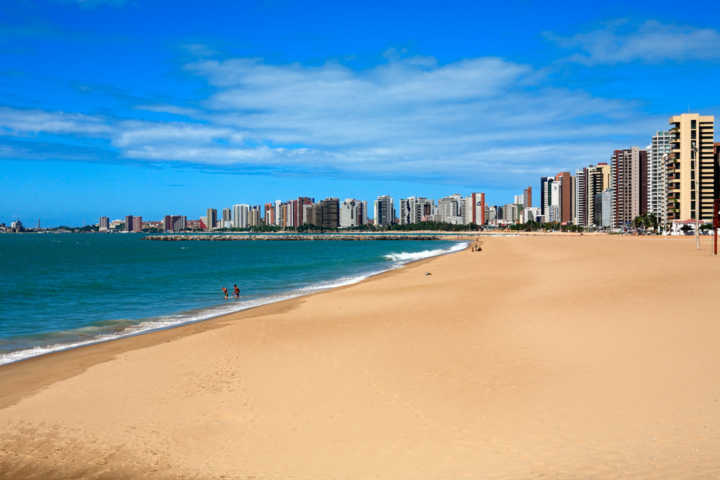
[[0, 243, 468, 365]]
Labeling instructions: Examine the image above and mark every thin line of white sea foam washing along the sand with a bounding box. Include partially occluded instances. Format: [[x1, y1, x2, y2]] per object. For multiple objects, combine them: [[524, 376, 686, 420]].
[[0, 243, 468, 365]]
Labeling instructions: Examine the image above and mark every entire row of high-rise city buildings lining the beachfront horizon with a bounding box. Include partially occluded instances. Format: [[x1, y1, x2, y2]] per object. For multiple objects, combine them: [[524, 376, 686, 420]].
[[99, 113, 720, 232]]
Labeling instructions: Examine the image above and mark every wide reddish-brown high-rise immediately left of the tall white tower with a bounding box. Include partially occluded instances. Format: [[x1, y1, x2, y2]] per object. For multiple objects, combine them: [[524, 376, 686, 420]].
[[611, 147, 648, 228]]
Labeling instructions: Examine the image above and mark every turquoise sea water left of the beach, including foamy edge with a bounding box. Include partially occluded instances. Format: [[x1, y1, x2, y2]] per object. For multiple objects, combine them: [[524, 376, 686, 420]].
[[0, 234, 462, 364]]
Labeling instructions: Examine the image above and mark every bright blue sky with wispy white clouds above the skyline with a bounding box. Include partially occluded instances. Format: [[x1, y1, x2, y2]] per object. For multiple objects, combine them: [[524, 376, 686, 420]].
[[0, 0, 720, 226]]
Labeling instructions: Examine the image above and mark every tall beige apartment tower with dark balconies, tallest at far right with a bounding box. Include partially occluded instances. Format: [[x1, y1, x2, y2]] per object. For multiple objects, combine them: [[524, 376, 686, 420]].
[[665, 113, 715, 222]]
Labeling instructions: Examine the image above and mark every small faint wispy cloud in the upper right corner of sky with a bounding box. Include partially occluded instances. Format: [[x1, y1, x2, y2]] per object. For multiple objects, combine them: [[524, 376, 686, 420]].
[[545, 20, 720, 65]]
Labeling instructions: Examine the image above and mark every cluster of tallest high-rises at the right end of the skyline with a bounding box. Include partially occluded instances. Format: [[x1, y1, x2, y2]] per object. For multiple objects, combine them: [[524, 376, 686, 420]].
[[523, 113, 720, 229]]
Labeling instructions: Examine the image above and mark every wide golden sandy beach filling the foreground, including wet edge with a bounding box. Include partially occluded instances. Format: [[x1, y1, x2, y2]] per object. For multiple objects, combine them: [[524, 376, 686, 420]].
[[0, 235, 720, 480]]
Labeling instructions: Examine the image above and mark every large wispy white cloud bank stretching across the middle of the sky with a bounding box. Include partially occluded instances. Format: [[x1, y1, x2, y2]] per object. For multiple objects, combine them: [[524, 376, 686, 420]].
[[0, 52, 656, 183]]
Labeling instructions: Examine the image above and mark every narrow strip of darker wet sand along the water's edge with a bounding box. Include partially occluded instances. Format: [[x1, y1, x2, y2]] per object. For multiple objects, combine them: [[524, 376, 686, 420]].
[[0, 242, 462, 410]]
